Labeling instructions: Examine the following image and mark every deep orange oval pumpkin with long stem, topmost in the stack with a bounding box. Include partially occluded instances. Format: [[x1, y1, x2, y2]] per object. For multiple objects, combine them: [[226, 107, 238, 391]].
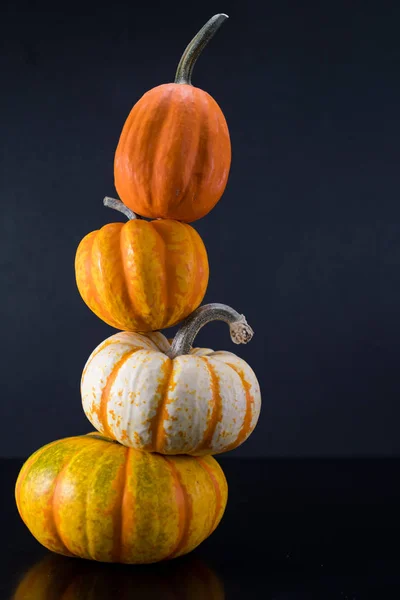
[[114, 15, 231, 222]]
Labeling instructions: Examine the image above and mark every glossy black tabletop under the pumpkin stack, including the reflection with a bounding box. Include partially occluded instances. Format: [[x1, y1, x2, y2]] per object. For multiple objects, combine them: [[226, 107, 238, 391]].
[[0, 458, 400, 600]]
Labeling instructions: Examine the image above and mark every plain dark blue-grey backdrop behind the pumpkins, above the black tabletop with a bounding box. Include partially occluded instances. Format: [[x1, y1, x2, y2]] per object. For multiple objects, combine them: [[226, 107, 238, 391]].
[[0, 0, 400, 457]]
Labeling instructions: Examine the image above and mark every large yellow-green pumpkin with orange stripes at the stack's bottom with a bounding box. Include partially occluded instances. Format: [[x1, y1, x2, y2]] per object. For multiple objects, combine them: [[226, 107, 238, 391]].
[[15, 434, 227, 563]]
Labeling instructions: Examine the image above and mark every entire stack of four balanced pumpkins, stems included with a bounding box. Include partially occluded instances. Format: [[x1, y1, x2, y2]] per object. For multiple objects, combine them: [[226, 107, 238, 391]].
[[16, 15, 260, 563]]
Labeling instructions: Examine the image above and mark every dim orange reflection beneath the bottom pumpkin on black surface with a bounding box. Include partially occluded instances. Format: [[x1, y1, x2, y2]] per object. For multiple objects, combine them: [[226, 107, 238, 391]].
[[13, 554, 225, 600]]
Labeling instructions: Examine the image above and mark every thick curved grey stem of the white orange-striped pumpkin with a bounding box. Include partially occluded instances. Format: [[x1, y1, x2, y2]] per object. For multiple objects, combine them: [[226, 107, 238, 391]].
[[169, 303, 254, 358]]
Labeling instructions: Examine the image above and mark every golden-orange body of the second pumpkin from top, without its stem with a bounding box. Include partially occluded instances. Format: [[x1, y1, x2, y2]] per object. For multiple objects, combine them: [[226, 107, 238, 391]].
[[75, 219, 209, 331]]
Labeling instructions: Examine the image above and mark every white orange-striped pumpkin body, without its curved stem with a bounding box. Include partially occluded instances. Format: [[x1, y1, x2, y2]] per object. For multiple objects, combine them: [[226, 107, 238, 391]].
[[81, 332, 261, 456]]
